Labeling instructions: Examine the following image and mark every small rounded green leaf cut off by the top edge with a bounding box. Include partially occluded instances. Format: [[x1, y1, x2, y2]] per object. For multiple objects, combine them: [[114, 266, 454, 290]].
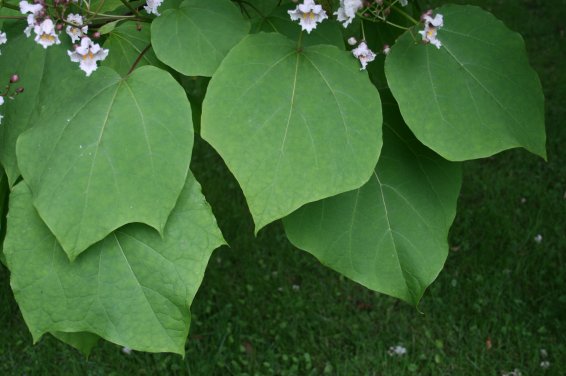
[[151, 0, 250, 76]]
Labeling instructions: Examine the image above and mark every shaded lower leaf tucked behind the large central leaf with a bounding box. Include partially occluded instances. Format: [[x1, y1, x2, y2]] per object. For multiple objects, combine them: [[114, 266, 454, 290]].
[[283, 94, 461, 305]]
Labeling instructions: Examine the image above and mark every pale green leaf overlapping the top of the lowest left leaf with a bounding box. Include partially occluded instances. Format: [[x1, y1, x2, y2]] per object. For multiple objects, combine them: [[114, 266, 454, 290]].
[[17, 66, 193, 259]]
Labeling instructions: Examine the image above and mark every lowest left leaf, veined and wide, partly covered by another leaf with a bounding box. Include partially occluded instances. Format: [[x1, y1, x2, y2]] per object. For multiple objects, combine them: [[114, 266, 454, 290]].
[[5, 174, 223, 354]]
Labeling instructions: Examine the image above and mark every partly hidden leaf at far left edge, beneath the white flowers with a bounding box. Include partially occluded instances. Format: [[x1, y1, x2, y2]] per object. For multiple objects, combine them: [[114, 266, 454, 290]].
[[0, 23, 78, 186]]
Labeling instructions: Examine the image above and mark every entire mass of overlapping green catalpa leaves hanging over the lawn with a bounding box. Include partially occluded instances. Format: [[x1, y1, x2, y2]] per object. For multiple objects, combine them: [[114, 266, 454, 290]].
[[0, 0, 546, 356]]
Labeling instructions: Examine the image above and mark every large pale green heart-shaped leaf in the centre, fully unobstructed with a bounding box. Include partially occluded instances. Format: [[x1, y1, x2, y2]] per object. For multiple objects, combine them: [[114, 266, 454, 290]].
[[202, 33, 382, 231]]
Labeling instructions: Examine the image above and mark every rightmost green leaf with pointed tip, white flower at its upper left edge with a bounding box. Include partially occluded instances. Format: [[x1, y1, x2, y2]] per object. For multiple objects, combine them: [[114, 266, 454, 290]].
[[385, 5, 546, 160]]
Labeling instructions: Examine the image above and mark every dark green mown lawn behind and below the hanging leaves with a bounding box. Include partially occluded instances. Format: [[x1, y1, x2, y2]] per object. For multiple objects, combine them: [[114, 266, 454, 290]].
[[0, 0, 566, 375]]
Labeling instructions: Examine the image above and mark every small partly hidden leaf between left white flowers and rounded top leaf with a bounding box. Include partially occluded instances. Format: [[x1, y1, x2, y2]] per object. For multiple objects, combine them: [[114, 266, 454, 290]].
[[101, 22, 163, 76]]
